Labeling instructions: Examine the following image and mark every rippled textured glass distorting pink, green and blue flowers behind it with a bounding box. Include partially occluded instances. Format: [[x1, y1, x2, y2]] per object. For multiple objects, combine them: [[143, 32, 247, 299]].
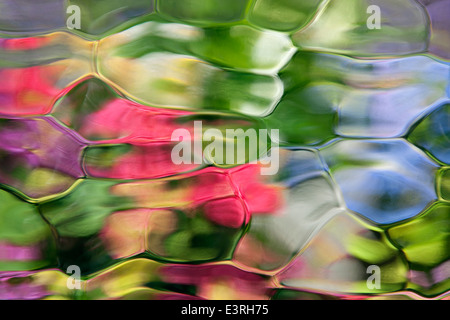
[[0, 0, 450, 300]]
